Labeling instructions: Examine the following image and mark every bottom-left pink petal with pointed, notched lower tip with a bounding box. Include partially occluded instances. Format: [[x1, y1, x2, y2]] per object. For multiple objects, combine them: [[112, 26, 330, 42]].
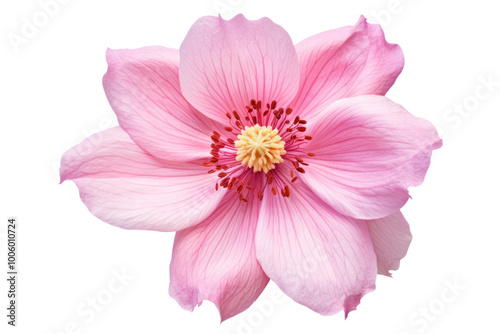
[[170, 192, 269, 321]]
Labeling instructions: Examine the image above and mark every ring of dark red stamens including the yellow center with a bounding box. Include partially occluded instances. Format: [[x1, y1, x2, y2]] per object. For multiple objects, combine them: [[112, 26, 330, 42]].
[[203, 99, 314, 202]]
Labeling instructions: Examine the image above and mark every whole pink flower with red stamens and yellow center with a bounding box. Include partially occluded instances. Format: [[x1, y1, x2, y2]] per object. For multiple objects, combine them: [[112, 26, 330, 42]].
[[61, 15, 442, 320]]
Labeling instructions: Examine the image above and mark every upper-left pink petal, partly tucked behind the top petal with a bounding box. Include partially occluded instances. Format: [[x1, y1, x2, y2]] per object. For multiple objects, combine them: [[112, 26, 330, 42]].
[[103, 47, 222, 161]]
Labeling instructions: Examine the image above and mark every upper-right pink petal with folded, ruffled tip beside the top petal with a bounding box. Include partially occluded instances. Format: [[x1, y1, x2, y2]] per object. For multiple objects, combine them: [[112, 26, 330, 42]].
[[292, 17, 404, 120]]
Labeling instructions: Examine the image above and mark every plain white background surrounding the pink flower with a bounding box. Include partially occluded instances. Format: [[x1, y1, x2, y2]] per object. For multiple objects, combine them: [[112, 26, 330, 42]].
[[0, 0, 500, 334]]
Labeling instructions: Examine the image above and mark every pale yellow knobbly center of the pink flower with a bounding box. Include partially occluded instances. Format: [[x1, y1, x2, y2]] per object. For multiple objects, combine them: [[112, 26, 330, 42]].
[[234, 124, 286, 173]]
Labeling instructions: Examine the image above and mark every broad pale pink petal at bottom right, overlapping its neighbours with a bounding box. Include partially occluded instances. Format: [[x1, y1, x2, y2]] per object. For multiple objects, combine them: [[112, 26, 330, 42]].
[[256, 182, 377, 316]]
